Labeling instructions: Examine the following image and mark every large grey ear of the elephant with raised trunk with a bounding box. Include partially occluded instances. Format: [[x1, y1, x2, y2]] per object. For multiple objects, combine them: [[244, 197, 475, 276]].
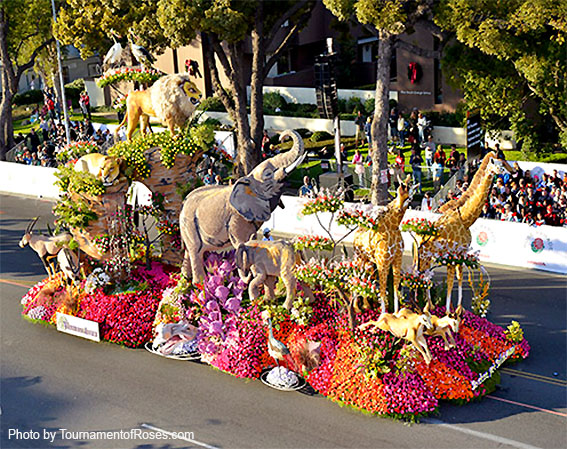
[[229, 176, 272, 221]]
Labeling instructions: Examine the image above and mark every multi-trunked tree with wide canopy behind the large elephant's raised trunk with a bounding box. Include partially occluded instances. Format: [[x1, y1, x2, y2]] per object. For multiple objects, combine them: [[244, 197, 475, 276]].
[[56, 0, 315, 174]]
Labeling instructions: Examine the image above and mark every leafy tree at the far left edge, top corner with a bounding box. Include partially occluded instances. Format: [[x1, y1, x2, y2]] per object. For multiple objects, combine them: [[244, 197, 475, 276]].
[[0, 0, 54, 160]]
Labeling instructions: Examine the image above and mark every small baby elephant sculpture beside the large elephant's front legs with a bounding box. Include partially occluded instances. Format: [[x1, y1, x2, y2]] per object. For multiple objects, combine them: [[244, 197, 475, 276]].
[[236, 240, 315, 310]]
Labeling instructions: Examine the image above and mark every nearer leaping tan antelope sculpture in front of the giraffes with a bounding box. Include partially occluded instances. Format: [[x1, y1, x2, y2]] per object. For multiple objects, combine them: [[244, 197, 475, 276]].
[[358, 308, 433, 365]]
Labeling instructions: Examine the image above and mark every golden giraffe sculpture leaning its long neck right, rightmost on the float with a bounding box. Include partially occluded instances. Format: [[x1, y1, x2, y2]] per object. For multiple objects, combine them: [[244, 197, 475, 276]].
[[417, 152, 514, 311]]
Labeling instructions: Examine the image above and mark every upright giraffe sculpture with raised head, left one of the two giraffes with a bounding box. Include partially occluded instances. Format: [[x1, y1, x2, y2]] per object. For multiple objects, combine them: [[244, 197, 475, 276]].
[[354, 176, 415, 313]]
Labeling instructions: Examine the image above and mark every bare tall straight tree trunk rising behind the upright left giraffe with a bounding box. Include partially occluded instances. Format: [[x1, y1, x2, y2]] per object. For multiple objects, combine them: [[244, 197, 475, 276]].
[[371, 33, 394, 205]]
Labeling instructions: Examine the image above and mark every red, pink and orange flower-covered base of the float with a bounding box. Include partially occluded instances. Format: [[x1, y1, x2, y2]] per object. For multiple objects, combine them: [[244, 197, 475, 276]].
[[22, 252, 529, 420]]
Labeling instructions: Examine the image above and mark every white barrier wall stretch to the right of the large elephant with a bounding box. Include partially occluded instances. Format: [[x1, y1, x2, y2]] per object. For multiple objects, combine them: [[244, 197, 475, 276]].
[[266, 196, 567, 274]]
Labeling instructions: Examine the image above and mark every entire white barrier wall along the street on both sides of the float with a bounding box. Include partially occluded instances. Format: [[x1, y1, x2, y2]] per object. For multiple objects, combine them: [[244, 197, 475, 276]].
[[0, 162, 567, 274]]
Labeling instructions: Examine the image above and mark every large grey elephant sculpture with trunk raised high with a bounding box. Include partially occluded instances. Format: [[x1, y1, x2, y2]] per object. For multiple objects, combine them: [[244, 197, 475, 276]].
[[179, 130, 305, 282]]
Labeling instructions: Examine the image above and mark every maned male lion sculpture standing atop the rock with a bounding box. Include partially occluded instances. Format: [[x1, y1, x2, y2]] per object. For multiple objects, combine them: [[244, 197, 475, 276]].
[[115, 73, 201, 141]]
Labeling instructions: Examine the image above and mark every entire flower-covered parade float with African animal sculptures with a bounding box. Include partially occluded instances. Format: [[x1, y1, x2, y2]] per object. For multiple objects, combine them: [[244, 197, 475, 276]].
[[21, 67, 529, 420]]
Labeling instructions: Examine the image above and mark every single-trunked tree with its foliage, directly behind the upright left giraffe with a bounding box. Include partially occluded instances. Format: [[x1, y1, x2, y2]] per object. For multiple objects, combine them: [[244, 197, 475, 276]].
[[323, 0, 447, 204]]
